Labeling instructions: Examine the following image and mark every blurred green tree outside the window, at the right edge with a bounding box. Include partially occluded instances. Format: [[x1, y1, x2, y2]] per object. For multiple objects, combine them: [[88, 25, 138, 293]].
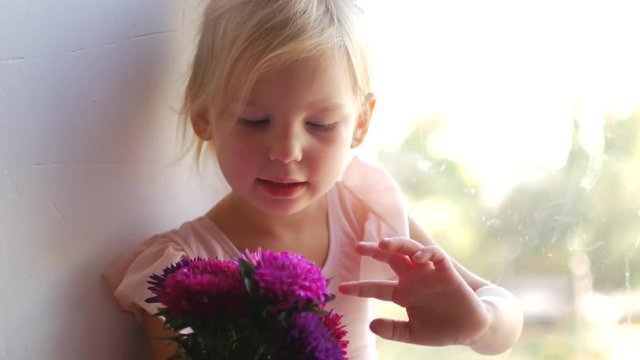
[[485, 113, 640, 290]]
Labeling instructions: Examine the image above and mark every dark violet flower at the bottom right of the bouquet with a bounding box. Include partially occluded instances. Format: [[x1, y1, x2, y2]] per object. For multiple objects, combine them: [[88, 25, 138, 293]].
[[275, 312, 345, 360]]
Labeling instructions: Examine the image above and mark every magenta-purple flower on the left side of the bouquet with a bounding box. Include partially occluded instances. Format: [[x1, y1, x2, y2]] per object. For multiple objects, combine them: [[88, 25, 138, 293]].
[[147, 259, 245, 317]]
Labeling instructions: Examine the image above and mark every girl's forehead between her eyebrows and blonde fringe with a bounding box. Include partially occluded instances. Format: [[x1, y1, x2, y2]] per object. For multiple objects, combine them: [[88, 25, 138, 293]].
[[247, 56, 355, 107]]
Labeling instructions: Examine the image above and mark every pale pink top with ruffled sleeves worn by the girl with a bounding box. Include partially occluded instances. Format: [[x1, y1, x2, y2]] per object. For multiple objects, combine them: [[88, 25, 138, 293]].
[[105, 158, 409, 359]]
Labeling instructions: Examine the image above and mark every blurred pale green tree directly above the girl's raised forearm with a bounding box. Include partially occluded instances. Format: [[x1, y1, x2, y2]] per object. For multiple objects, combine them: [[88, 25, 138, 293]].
[[378, 118, 506, 278]]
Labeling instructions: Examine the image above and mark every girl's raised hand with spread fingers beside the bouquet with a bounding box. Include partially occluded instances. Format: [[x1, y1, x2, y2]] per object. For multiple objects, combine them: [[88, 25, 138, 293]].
[[339, 238, 491, 346]]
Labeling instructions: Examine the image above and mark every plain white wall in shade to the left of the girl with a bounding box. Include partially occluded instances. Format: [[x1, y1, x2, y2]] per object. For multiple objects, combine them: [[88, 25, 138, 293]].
[[0, 0, 222, 360]]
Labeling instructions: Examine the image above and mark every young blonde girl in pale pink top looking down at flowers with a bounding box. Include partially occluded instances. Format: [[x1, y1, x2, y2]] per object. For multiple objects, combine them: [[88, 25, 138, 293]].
[[106, 0, 522, 359]]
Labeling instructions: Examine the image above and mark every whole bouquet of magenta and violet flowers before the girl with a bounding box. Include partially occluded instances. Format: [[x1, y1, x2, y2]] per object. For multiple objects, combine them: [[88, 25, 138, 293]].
[[146, 249, 348, 360]]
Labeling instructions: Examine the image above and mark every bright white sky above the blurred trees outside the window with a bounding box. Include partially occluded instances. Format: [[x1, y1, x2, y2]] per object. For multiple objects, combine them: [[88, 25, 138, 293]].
[[363, 0, 640, 205]]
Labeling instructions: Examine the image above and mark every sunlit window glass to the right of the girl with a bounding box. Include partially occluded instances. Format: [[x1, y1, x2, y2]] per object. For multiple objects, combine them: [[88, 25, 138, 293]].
[[363, 0, 640, 360]]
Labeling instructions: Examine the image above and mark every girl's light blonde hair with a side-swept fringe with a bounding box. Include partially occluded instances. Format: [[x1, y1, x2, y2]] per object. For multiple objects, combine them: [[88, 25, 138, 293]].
[[182, 0, 371, 163]]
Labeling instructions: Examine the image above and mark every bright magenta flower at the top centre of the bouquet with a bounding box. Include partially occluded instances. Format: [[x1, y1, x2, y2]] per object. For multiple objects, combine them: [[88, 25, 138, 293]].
[[244, 249, 330, 309]]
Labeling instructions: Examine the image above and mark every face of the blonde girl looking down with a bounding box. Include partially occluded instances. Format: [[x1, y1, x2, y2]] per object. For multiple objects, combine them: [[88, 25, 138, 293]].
[[212, 57, 373, 215]]
